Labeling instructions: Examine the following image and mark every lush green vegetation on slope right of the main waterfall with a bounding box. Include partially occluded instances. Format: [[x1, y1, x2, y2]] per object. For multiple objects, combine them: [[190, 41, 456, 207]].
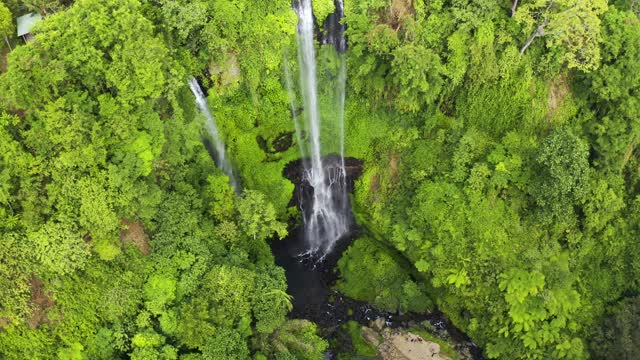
[[347, 0, 640, 359]]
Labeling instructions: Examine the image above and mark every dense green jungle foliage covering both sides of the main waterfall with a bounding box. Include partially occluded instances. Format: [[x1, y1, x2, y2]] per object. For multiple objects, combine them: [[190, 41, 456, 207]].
[[0, 0, 640, 360]]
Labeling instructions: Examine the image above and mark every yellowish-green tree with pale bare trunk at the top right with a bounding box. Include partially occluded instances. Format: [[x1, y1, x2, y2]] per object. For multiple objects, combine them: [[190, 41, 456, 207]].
[[515, 0, 607, 71]]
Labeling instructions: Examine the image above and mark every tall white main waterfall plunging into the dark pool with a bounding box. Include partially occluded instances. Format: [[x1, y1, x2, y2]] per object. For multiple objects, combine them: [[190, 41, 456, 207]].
[[287, 0, 351, 256]]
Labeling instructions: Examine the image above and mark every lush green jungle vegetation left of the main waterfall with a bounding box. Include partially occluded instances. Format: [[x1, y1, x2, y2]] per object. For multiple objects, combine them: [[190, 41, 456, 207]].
[[0, 0, 326, 359]]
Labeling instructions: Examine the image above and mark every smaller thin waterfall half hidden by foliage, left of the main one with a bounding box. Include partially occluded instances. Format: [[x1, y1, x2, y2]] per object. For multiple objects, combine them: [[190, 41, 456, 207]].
[[189, 77, 239, 192]]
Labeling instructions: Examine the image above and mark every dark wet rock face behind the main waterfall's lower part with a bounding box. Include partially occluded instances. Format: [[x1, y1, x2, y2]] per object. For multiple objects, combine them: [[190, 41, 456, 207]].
[[282, 154, 363, 207]]
